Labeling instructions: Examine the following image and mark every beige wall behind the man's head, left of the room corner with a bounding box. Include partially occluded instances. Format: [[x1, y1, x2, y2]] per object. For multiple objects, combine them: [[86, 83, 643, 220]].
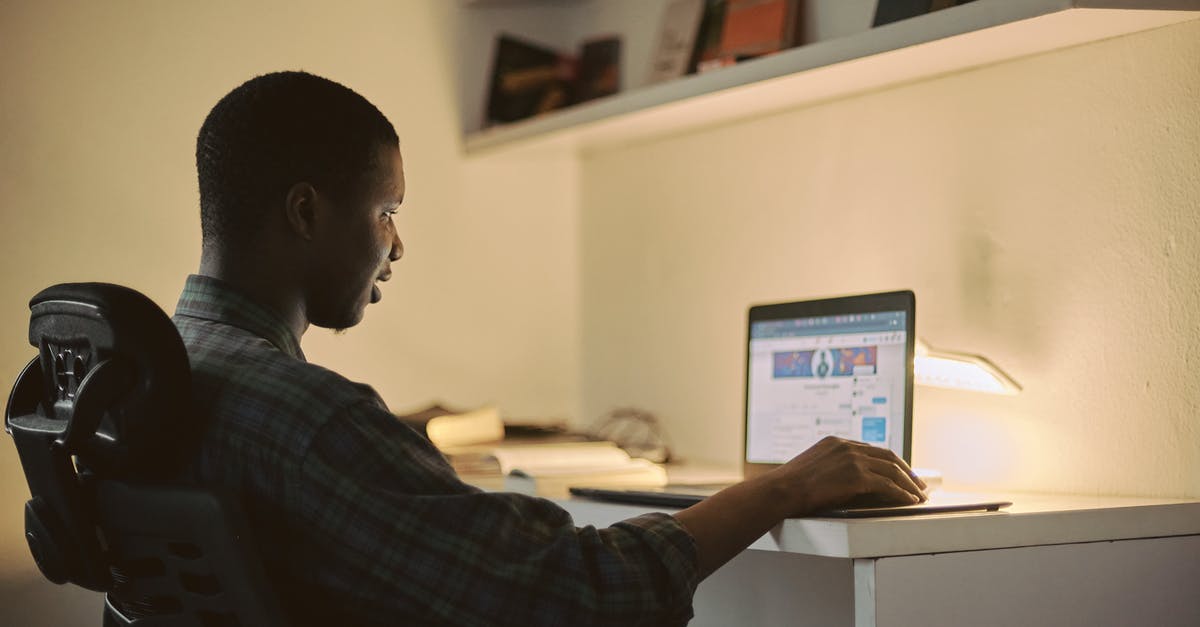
[[0, 0, 578, 626]]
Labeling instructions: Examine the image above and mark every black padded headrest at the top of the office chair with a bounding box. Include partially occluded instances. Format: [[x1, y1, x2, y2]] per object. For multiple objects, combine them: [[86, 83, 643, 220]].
[[29, 283, 200, 478]]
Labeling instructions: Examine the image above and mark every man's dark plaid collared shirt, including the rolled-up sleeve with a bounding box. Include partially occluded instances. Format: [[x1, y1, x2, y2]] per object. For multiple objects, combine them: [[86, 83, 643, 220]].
[[174, 275, 698, 626]]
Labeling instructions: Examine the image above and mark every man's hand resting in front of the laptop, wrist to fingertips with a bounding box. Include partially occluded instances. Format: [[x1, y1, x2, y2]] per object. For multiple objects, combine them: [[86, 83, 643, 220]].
[[767, 436, 925, 518]]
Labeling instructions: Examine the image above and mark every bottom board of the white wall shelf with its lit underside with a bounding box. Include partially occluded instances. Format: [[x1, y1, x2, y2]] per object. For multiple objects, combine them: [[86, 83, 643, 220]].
[[463, 0, 1200, 154]]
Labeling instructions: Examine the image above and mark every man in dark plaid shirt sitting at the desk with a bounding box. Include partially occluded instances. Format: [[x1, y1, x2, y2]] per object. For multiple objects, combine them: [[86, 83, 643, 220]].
[[174, 72, 924, 626]]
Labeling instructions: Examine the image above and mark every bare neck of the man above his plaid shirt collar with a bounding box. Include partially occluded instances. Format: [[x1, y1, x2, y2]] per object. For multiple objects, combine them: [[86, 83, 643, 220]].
[[198, 249, 308, 341]]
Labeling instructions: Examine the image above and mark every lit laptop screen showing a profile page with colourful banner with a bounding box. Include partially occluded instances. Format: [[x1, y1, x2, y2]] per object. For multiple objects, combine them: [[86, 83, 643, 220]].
[[746, 311, 907, 464]]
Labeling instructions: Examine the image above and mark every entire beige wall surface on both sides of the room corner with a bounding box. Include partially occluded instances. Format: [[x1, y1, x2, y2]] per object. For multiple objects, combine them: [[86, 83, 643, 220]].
[[0, 0, 1200, 625]]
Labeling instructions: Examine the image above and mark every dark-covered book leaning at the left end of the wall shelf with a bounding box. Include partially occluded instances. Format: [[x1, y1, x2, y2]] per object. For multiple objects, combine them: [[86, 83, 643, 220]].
[[485, 35, 574, 126]]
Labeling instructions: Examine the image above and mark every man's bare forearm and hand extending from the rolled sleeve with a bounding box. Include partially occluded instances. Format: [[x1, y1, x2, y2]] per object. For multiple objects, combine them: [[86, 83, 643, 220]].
[[676, 437, 925, 578]]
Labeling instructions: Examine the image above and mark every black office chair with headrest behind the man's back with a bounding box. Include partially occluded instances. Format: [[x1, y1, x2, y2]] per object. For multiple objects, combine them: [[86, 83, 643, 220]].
[[5, 283, 283, 627]]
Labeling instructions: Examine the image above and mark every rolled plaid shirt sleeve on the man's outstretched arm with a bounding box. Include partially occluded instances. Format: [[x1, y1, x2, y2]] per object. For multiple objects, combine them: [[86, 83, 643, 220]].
[[293, 400, 698, 626]]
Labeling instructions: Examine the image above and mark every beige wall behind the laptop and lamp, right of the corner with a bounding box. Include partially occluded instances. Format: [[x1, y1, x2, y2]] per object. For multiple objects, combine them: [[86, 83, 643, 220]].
[[581, 22, 1200, 496]]
